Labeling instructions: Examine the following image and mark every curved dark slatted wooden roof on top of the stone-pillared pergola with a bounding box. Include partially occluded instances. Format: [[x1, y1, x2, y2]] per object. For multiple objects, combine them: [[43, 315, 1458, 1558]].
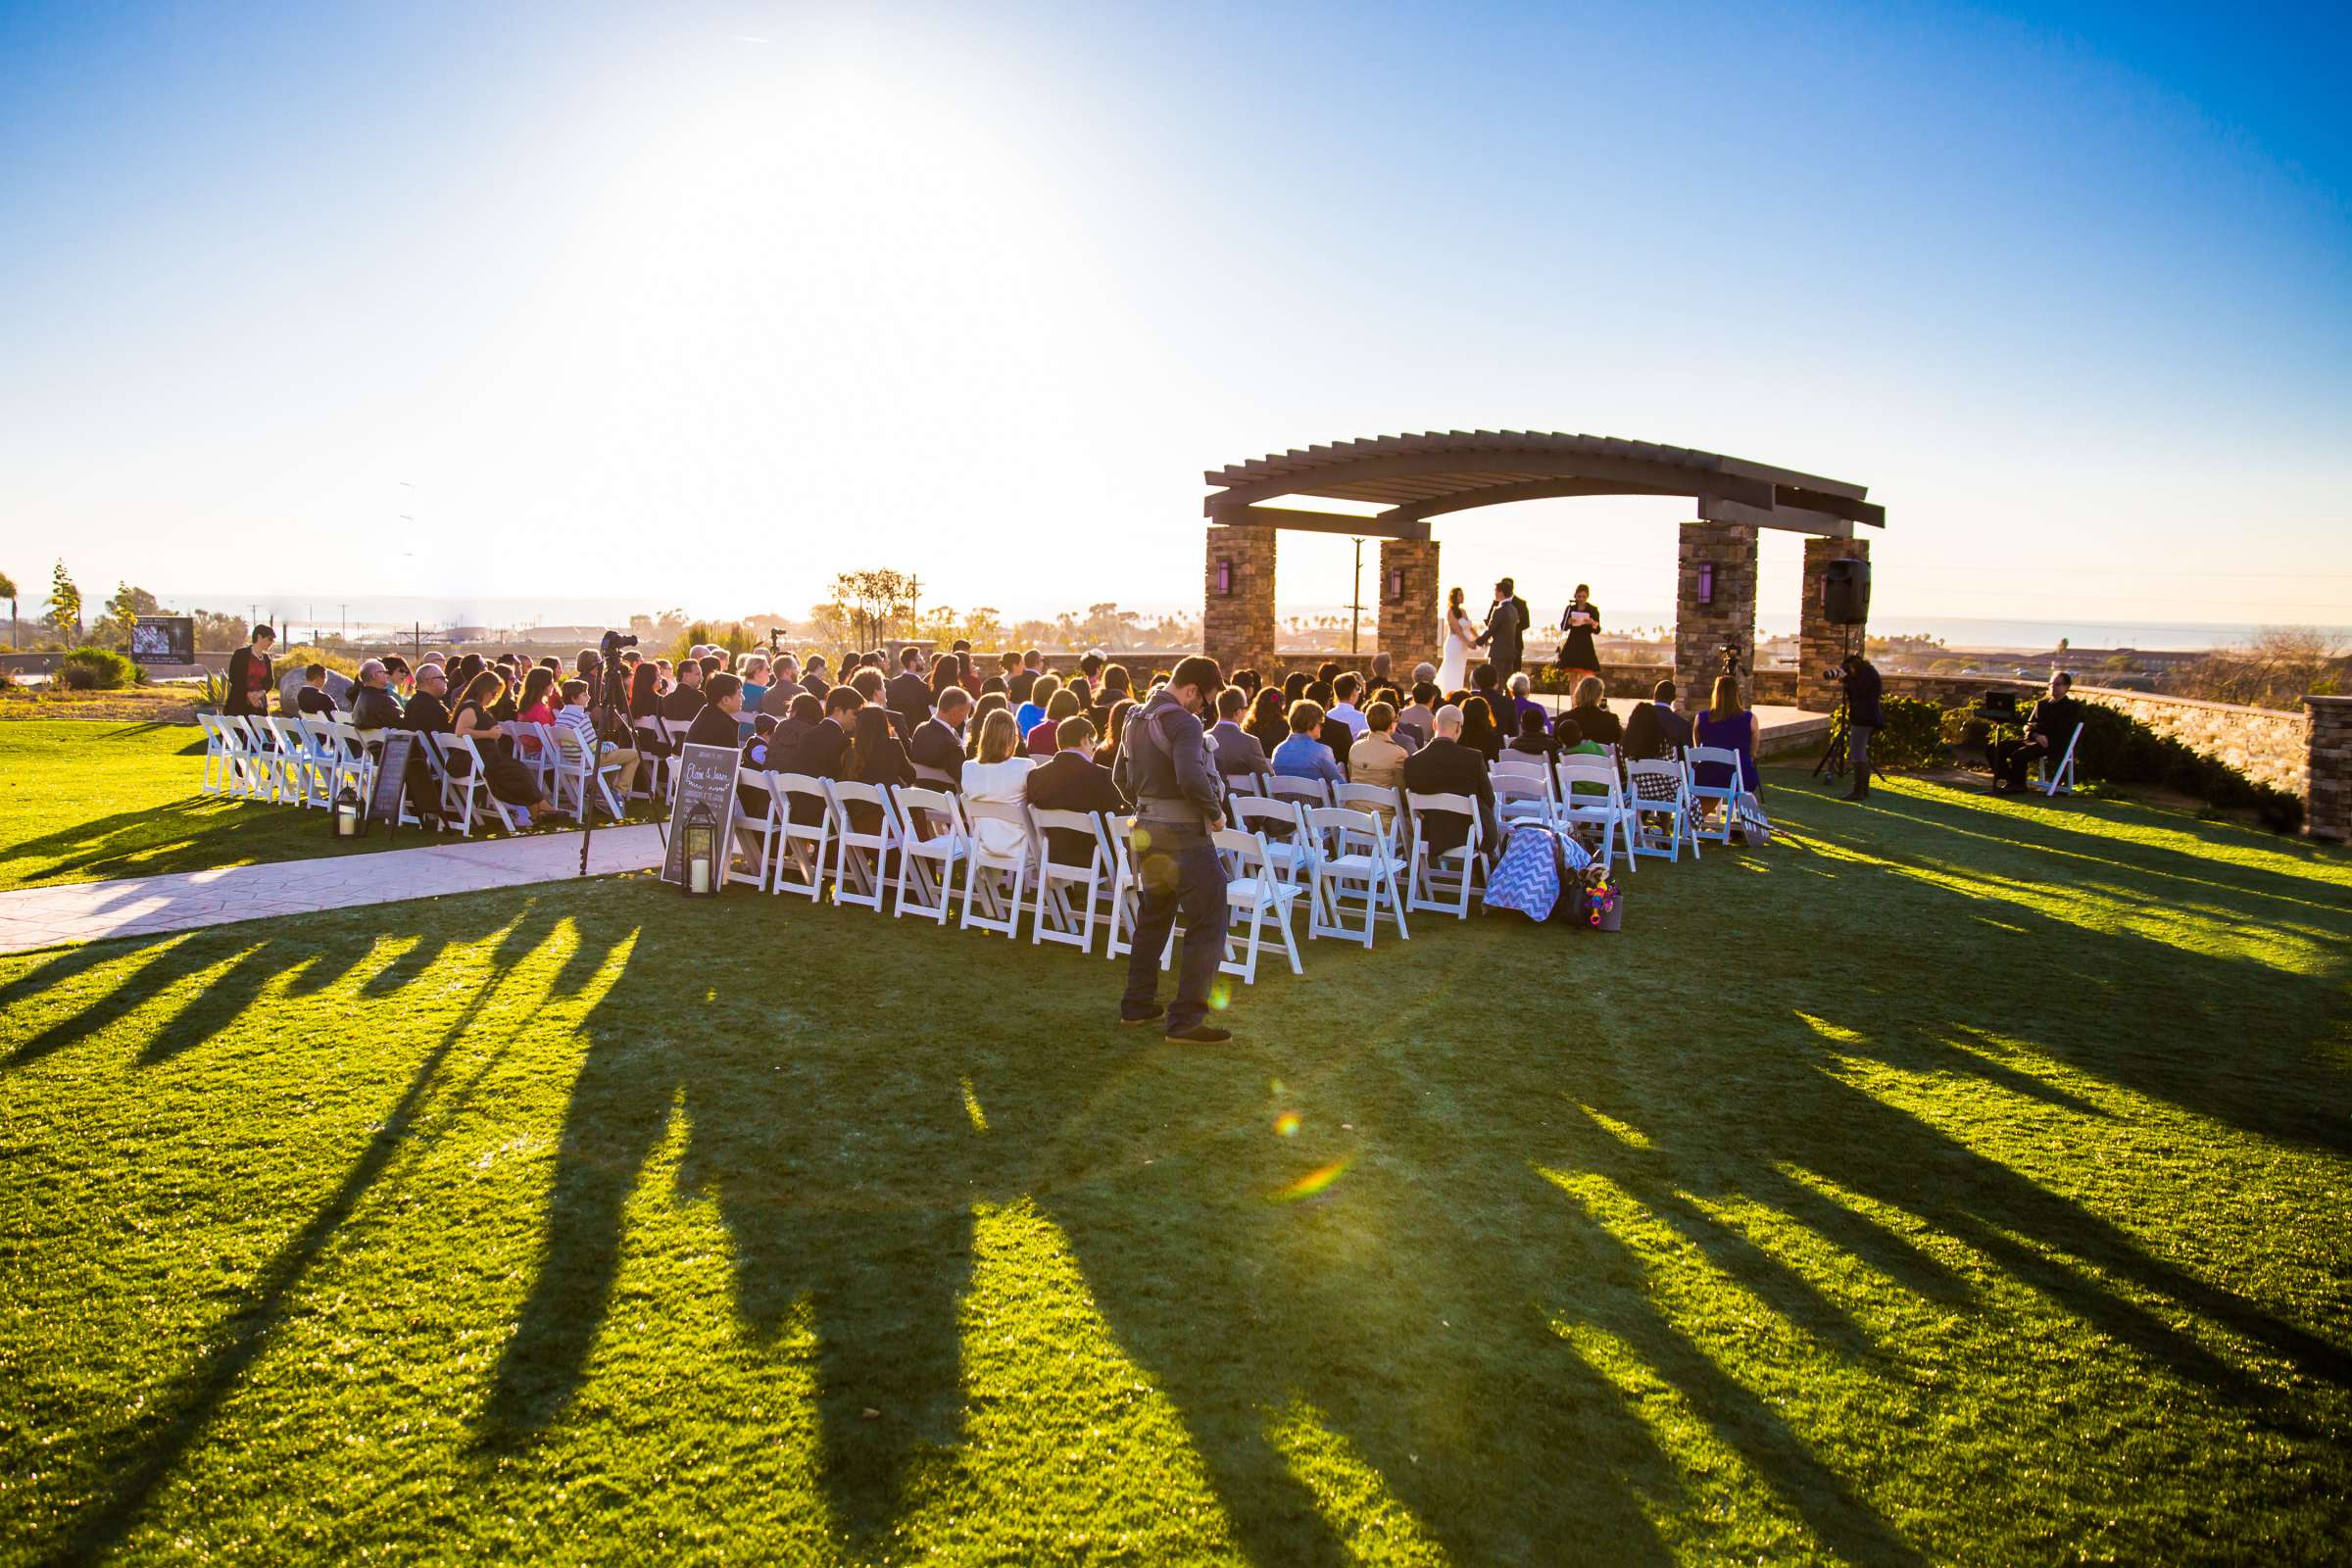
[[1201, 430, 1886, 538]]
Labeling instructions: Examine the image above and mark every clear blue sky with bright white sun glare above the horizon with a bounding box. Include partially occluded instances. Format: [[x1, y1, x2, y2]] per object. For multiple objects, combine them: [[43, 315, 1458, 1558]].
[[0, 5, 2352, 627]]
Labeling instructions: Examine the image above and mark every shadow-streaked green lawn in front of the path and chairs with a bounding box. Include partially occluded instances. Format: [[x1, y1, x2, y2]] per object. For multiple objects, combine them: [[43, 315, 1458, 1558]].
[[0, 752, 2352, 1563]]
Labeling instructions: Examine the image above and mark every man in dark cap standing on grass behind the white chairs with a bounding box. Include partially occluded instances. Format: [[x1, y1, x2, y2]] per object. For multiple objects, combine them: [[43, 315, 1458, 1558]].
[[1119, 654, 1233, 1046]]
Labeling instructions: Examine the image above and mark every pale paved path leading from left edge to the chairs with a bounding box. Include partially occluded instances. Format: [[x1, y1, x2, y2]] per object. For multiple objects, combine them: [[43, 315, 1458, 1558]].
[[0, 823, 661, 953]]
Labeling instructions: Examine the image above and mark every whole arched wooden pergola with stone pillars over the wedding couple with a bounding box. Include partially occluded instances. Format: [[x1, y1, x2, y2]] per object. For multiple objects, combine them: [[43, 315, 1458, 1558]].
[[1201, 430, 1886, 706]]
